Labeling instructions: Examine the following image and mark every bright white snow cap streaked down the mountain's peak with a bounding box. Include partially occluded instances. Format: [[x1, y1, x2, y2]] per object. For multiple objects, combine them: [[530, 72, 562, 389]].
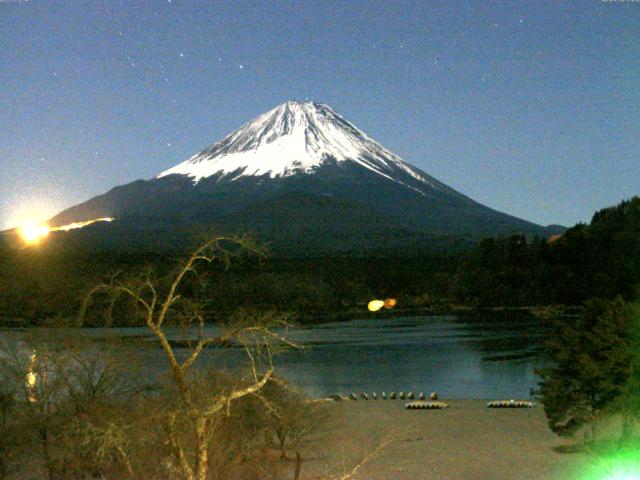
[[156, 101, 457, 193]]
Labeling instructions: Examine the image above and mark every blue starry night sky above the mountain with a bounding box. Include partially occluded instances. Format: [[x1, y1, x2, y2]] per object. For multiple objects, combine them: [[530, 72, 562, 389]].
[[0, 0, 640, 231]]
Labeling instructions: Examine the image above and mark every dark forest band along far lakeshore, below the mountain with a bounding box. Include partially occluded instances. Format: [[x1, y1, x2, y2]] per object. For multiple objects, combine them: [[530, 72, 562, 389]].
[[0, 197, 640, 325]]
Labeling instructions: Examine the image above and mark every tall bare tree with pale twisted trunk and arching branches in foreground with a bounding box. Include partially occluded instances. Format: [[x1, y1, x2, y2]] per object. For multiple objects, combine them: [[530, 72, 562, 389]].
[[78, 237, 294, 480]]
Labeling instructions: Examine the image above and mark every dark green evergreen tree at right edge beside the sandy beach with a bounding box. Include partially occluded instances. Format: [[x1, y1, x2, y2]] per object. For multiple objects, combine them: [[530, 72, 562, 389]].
[[538, 297, 637, 435]]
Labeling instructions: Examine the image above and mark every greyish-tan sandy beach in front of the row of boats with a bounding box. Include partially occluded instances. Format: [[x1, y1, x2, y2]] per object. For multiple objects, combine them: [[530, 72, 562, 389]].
[[303, 400, 589, 480]]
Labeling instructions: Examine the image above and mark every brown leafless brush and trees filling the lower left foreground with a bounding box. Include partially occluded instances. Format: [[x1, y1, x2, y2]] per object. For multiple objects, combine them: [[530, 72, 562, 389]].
[[0, 332, 340, 480]]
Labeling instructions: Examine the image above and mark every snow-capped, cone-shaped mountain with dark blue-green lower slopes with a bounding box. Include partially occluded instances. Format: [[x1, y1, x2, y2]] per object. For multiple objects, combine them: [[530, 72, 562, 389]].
[[49, 101, 552, 254]]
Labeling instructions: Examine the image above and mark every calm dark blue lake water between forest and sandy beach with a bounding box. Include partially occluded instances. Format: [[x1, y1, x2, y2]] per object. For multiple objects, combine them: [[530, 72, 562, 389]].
[[1, 313, 546, 399]]
